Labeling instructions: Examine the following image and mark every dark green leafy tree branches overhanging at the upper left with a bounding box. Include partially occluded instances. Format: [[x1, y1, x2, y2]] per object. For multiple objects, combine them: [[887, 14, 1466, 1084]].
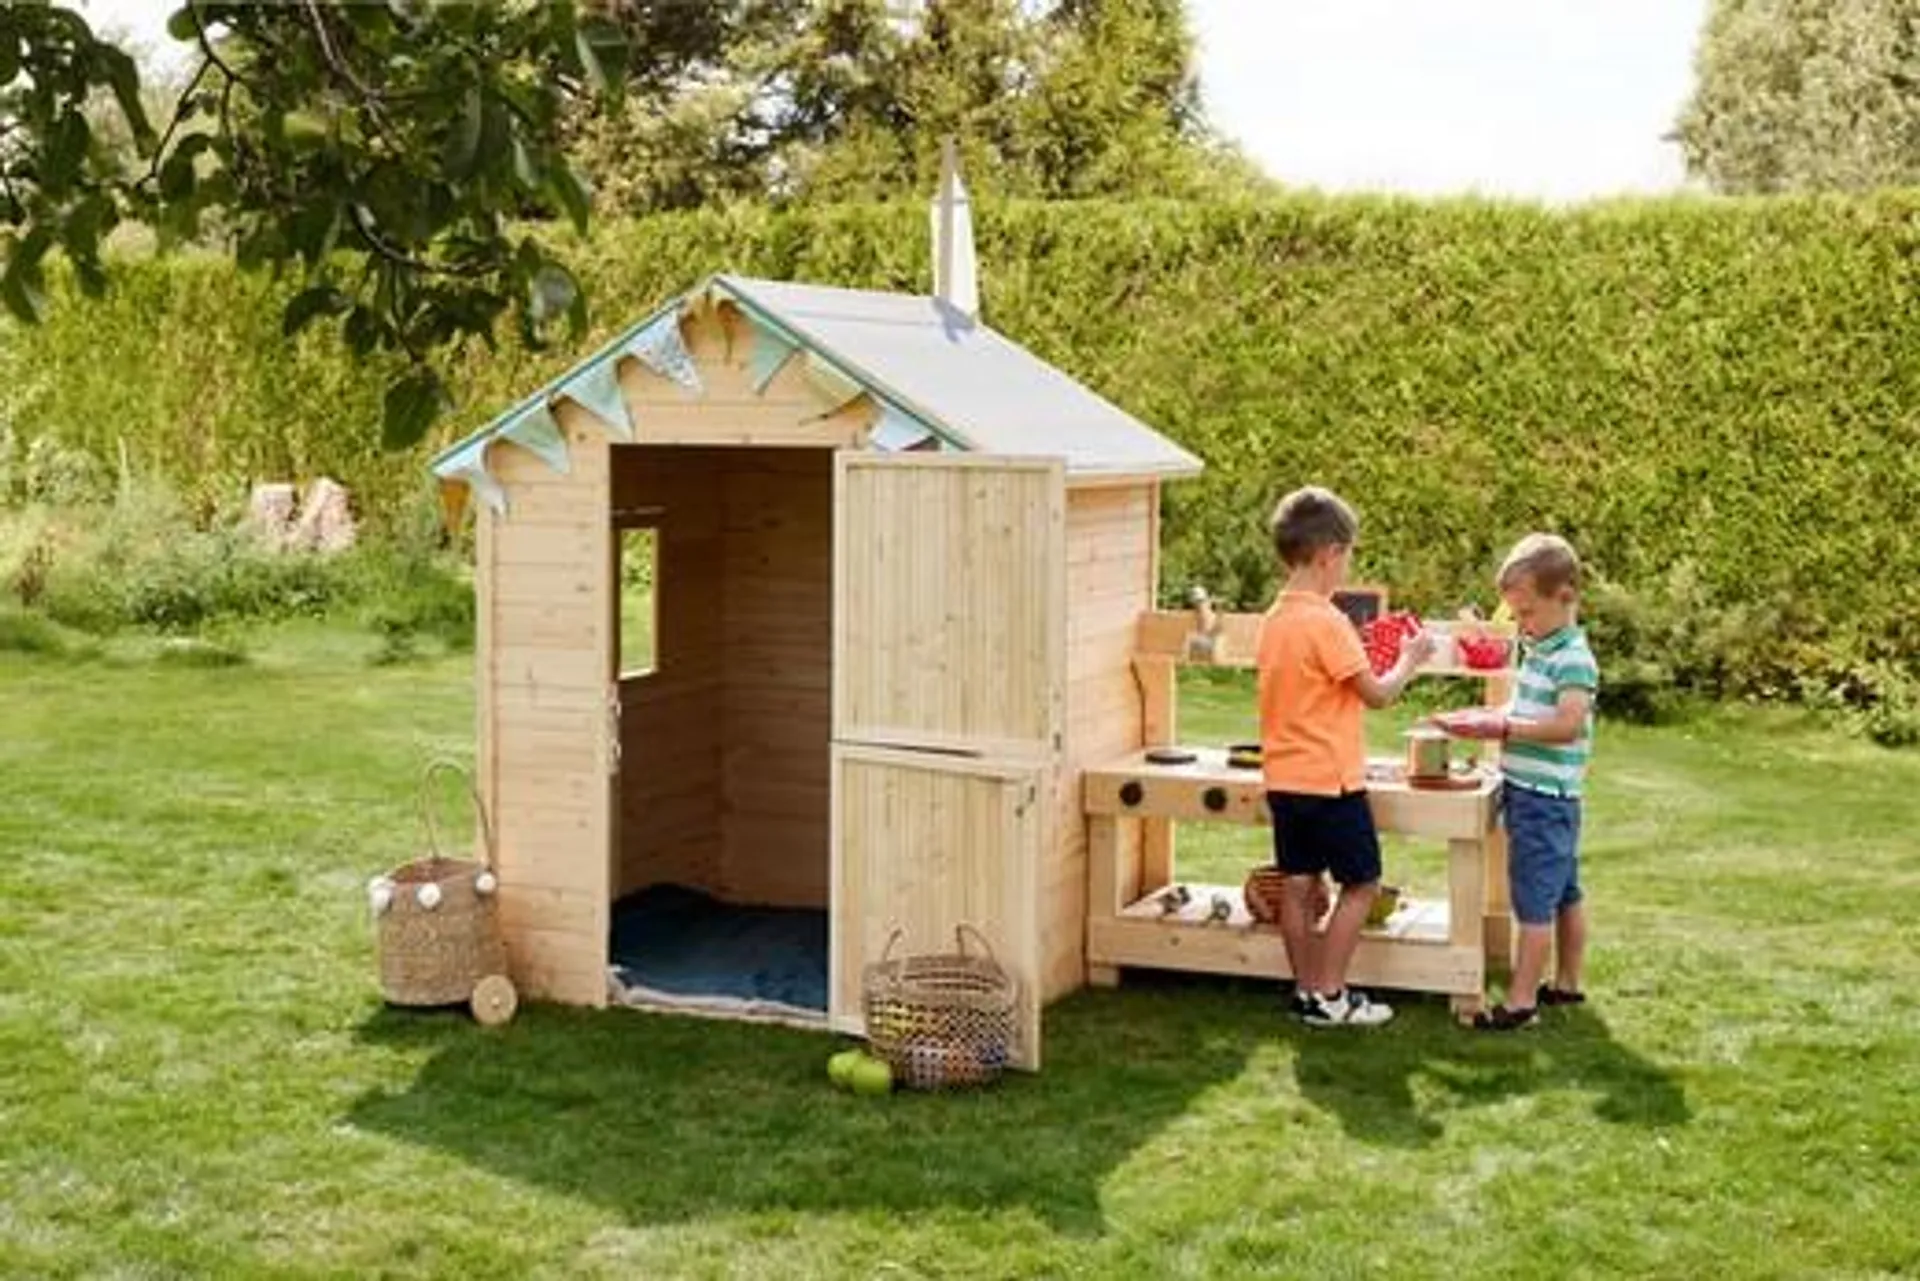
[[0, 4, 633, 451]]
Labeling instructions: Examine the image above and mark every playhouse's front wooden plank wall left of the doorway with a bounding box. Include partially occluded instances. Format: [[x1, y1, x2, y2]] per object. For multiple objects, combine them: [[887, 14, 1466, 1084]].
[[476, 405, 611, 1004]]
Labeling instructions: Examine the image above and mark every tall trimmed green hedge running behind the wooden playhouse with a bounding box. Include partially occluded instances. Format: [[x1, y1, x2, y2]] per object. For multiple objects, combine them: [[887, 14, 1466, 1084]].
[[0, 196, 1920, 702]]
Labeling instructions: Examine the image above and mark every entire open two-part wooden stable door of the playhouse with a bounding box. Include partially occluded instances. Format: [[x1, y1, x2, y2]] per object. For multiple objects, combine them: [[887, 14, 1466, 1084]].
[[829, 453, 1066, 1068]]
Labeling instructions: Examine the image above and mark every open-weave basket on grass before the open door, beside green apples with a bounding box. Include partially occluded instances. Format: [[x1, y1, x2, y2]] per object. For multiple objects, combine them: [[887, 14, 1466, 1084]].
[[862, 926, 1016, 1089]]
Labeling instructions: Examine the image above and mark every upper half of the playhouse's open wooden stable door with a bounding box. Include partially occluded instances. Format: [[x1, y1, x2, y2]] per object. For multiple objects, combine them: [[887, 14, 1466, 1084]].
[[835, 455, 1066, 757]]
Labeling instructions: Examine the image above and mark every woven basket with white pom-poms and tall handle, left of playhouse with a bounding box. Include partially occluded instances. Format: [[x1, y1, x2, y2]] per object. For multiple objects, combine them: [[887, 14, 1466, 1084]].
[[374, 761, 507, 1004]]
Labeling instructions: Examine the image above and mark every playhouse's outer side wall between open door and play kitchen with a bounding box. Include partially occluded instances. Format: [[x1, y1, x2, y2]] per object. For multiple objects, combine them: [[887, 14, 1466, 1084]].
[[1039, 484, 1156, 1001]]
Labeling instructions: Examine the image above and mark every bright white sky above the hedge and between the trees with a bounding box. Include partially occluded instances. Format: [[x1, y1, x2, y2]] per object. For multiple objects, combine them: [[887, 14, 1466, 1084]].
[[81, 0, 1707, 202]]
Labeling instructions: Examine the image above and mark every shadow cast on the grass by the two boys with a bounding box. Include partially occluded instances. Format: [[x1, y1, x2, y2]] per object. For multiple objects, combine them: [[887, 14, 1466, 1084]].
[[1288, 999, 1692, 1147]]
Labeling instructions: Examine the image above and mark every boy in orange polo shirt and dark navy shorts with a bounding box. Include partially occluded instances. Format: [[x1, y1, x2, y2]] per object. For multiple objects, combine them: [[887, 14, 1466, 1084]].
[[1260, 486, 1432, 1027]]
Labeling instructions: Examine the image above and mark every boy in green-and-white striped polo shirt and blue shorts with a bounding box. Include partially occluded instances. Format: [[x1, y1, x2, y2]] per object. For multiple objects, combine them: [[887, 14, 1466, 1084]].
[[1436, 534, 1599, 1031]]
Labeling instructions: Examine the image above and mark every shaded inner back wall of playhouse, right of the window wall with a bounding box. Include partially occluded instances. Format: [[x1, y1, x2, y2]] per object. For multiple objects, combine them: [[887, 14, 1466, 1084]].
[[710, 449, 833, 908]]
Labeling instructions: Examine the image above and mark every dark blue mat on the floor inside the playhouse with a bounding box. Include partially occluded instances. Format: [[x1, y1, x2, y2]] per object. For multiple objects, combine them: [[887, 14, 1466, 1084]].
[[611, 885, 828, 1018]]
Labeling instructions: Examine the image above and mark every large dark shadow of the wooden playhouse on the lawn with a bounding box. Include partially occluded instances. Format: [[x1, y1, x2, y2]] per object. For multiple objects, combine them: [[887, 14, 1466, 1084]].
[[349, 989, 1273, 1235]]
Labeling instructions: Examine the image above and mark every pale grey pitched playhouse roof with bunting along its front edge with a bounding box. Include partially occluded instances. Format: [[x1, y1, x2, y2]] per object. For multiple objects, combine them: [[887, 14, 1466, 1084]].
[[434, 275, 1200, 491]]
